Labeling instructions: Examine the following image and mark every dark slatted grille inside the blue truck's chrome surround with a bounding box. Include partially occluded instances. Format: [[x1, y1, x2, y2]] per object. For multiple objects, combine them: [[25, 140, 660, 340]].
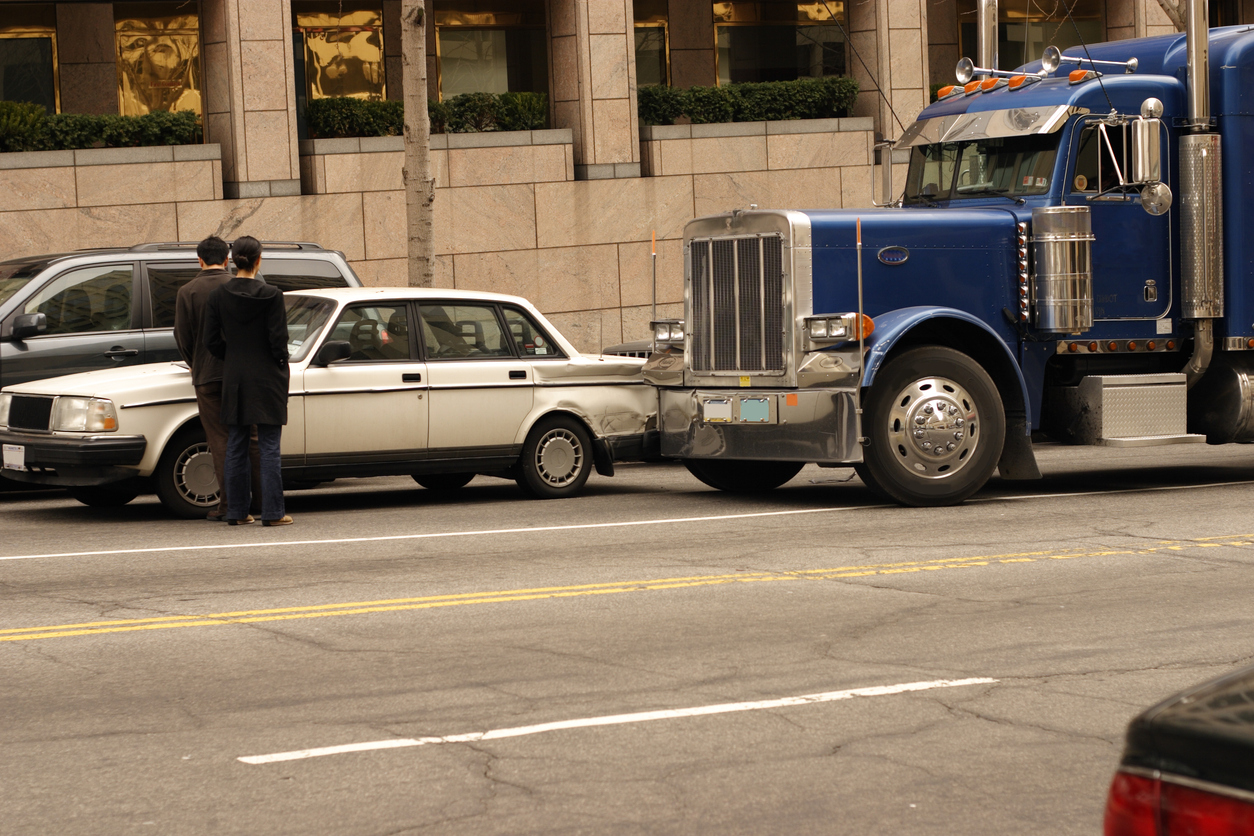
[[691, 236, 784, 374]]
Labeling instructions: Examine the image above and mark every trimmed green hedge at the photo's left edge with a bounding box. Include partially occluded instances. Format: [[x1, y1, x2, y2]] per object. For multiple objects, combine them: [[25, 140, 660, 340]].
[[0, 102, 201, 152]]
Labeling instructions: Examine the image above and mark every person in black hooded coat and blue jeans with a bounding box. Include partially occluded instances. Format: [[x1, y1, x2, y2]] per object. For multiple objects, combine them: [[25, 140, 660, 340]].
[[204, 236, 292, 525]]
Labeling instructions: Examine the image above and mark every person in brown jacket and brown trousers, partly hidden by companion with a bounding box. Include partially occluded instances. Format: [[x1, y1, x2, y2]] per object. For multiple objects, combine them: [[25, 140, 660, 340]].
[[174, 236, 261, 521]]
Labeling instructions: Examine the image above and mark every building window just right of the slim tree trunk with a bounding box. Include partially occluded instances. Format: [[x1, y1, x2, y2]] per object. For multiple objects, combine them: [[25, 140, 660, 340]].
[[433, 0, 548, 99]]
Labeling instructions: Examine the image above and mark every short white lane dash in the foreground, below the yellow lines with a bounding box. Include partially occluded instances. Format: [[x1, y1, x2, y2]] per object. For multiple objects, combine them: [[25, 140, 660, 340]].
[[236, 677, 997, 763]]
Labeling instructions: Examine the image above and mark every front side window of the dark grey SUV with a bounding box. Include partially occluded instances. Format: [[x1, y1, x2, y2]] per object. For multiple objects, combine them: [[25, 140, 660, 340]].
[[24, 264, 133, 333]]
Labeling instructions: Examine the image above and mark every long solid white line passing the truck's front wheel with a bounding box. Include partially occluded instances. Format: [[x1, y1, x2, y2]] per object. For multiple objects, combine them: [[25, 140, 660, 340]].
[[0, 480, 1254, 562]]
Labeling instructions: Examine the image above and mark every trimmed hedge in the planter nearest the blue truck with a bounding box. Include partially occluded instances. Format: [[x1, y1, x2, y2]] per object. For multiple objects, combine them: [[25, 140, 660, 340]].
[[636, 76, 858, 125]]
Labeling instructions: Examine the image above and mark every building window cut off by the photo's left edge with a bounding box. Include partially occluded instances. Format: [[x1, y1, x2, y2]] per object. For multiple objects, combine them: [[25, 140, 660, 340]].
[[0, 4, 60, 113]]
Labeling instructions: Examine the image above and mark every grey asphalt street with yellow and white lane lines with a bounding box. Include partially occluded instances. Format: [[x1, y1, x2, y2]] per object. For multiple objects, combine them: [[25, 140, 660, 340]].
[[0, 445, 1254, 836]]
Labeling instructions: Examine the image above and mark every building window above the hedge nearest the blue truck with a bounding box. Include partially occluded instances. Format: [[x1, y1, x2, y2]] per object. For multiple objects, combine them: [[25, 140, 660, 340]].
[[714, 0, 845, 84]]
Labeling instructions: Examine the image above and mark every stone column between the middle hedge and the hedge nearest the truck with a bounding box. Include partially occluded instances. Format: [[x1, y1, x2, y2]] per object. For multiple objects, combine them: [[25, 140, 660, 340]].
[[548, 0, 640, 180]]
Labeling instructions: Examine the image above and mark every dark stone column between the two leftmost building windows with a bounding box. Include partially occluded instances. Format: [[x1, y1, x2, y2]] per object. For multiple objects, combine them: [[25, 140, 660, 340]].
[[56, 3, 118, 114]]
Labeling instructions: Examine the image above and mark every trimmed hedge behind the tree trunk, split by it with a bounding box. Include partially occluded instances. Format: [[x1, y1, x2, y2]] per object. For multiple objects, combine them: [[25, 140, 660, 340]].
[[305, 93, 548, 139]]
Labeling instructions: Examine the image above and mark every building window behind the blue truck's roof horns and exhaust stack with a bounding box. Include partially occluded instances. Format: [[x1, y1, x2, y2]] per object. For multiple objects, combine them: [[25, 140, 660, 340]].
[[958, 0, 1106, 70]]
